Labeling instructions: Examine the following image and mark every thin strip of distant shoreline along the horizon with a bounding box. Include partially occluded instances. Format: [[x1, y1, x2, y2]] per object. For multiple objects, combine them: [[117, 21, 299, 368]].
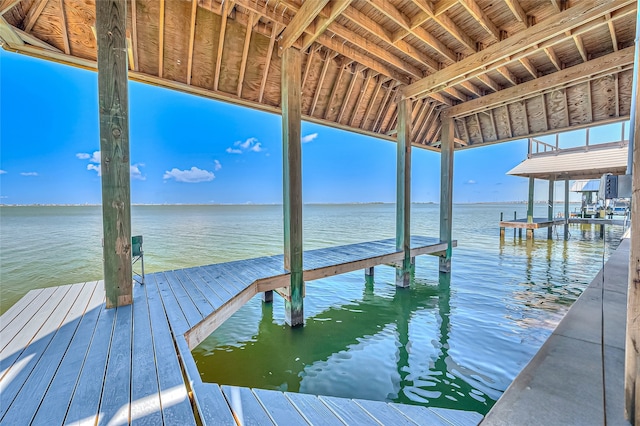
[[0, 200, 580, 207]]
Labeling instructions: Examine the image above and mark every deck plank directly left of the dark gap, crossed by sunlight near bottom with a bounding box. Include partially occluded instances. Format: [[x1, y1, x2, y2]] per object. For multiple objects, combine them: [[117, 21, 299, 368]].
[[145, 274, 195, 425]]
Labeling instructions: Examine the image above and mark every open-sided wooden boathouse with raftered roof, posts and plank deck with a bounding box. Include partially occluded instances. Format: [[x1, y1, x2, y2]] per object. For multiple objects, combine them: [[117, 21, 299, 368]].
[[0, 0, 640, 424]]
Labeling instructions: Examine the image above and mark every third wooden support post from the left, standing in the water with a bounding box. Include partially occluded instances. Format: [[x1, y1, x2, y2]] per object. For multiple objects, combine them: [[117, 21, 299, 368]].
[[396, 99, 411, 287]]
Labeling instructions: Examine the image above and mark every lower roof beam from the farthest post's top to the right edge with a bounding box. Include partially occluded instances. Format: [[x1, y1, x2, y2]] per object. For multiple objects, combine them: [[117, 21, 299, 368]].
[[449, 46, 635, 117]]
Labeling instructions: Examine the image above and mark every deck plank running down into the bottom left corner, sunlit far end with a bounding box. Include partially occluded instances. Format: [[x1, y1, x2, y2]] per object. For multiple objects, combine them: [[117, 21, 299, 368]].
[[0, 284, 95, 424]]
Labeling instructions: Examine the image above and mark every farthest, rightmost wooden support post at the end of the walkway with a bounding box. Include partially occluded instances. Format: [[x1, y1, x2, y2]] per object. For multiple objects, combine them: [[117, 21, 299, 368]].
[[439, 113, 454, 272]]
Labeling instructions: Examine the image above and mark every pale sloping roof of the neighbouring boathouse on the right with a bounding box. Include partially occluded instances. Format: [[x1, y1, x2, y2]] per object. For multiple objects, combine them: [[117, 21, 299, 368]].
[[507, 145, 628, 180]]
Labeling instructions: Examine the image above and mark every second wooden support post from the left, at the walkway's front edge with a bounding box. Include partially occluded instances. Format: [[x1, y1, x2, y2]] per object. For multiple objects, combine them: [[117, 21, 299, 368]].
[[282, 48, 304, 327]]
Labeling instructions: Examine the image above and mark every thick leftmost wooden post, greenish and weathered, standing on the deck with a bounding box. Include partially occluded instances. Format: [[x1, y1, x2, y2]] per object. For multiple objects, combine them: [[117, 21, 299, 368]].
[[96, 0, 133, 308]]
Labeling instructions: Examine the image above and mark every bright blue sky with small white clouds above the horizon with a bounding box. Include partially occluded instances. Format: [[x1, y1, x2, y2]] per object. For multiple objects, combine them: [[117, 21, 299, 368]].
[[0, 49, 632, 204]]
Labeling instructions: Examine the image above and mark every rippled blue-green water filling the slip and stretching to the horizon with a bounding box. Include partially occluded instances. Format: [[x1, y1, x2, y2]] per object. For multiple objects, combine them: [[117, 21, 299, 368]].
[[0, 204, 623, 414]]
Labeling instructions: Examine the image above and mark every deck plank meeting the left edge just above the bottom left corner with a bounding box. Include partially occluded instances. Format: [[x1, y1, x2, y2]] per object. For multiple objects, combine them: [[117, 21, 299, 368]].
[[0, 284, 84, 418]]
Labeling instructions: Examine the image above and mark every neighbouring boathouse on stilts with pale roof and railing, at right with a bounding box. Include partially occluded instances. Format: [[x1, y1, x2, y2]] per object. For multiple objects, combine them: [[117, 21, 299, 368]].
[[500, 129, 629, 239]]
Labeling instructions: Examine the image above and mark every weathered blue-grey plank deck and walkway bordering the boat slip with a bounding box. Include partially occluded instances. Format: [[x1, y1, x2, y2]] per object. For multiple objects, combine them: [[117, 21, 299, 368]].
[[0, 237, 482, 425]]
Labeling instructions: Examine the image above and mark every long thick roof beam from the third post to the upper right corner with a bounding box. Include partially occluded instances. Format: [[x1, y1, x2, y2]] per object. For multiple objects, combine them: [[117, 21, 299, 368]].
[[403, 0, 634, 98]]
